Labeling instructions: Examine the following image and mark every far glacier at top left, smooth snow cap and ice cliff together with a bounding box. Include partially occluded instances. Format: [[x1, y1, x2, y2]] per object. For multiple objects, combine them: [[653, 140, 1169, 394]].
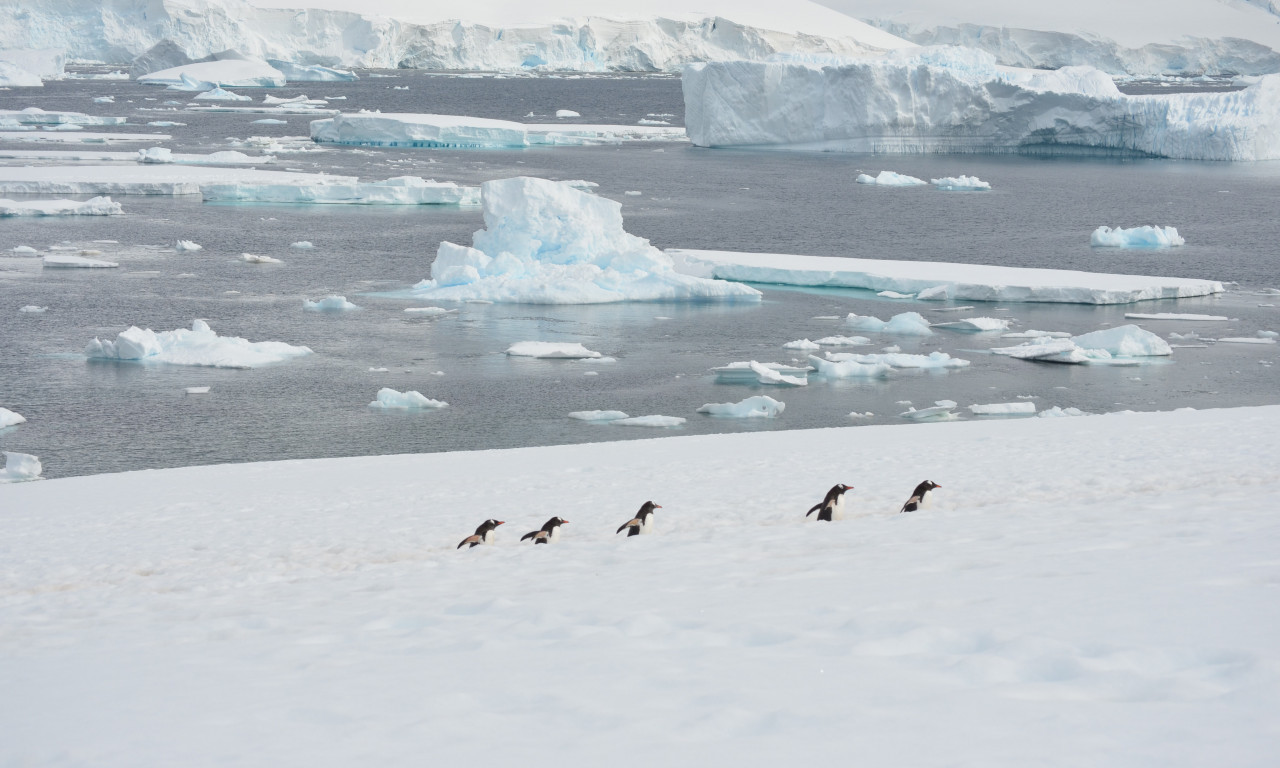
[[0, 0, 910, 73]]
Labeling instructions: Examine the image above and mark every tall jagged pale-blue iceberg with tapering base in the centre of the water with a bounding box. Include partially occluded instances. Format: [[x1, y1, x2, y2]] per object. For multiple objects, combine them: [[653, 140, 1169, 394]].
[[396, 177, 760, 303]]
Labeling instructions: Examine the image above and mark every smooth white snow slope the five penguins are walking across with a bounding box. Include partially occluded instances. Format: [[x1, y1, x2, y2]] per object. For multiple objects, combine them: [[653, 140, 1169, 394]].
[[0, 407, 1280, 768]]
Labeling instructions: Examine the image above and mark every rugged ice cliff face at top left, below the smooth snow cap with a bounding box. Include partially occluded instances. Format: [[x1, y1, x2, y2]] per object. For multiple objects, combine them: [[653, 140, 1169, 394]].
[[0, 0, 908, 72]]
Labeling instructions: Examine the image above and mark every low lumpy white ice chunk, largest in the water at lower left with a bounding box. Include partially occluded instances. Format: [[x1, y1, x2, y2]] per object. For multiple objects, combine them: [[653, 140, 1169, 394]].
[[84, 320, 311, 369]]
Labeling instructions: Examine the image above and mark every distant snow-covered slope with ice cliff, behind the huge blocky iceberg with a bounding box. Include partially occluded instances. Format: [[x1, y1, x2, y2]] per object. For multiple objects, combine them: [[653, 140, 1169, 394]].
[[819, 0, 1280, 76]]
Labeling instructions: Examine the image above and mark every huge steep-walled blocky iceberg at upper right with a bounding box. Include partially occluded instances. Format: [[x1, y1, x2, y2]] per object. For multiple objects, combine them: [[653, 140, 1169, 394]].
[[684, 47, 1280, 160]]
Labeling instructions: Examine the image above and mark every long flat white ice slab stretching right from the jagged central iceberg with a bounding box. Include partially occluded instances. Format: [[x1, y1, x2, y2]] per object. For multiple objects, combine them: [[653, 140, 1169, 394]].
[[667, 248, 1222, 305]]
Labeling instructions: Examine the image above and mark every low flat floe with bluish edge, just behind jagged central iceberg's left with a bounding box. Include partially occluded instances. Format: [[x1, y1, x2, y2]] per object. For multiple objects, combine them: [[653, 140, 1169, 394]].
[[200, 177, 480, 206]]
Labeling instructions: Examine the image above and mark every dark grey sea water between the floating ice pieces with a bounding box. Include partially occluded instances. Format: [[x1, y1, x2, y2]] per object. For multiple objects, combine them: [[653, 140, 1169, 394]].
[[0, 72, 1280, 477]]
